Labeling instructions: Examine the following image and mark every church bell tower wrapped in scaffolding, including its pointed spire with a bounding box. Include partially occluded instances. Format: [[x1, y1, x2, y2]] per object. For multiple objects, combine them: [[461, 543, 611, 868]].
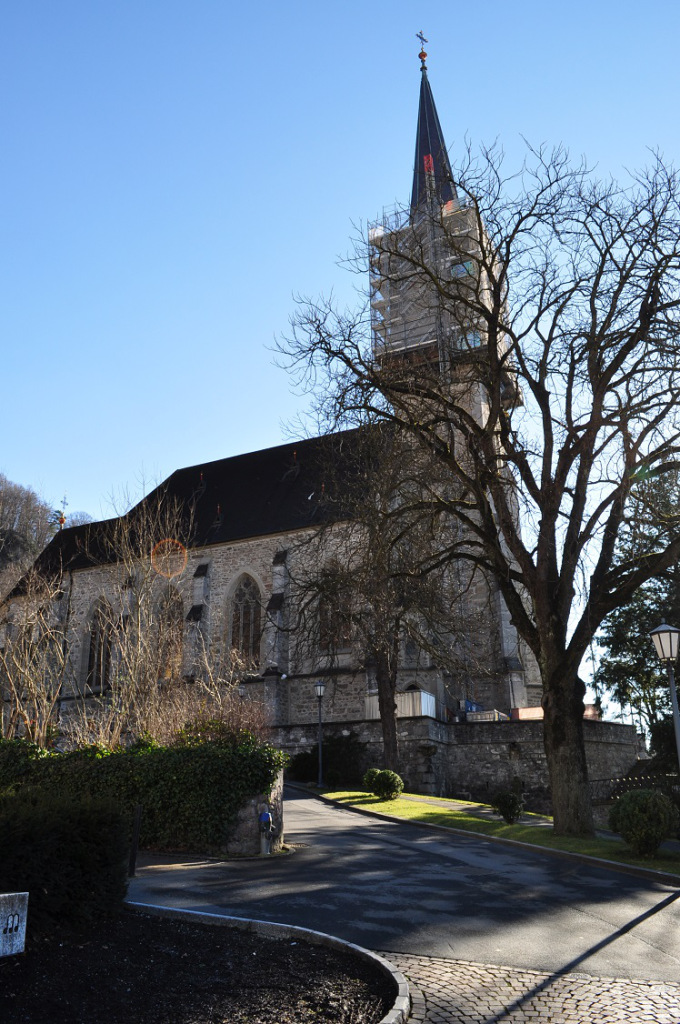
[[368, 41, 535, 708]]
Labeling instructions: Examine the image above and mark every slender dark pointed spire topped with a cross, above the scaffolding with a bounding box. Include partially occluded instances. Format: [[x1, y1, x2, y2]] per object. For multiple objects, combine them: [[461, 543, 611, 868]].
[[411, 32, 456, 218]]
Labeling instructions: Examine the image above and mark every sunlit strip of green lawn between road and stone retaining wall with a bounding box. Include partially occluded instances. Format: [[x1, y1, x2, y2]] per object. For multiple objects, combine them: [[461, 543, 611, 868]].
[[324, 791, 680, 876]]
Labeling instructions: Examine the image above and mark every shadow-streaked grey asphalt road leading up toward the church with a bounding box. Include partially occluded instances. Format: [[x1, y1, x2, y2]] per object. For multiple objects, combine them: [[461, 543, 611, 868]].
[[129, 793, 680, 982]]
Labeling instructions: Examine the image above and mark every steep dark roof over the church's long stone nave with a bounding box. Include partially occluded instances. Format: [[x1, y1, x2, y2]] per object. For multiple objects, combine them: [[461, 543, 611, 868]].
[[18, 430, 357, 596]]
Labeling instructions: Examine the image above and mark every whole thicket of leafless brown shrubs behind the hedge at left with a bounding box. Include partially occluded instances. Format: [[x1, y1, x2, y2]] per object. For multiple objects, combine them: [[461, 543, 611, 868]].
[[0, 486, 266, 749]]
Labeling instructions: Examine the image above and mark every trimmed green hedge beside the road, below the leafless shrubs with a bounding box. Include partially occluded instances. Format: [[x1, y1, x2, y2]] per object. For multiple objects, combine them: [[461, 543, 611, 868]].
[[0, 733, 286, 852]]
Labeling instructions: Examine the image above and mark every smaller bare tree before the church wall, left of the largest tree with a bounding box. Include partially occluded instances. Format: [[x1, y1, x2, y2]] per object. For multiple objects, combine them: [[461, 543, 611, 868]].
[[290, 423, 493, 771]]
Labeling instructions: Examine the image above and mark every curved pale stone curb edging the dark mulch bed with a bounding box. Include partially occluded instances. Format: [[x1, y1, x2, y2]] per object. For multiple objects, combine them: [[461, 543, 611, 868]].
[[125, 900, 411, 1024]]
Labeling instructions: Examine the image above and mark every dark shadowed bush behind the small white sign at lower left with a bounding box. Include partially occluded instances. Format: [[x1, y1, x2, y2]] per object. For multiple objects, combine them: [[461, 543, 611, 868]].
[[0, 787, 129, 934]]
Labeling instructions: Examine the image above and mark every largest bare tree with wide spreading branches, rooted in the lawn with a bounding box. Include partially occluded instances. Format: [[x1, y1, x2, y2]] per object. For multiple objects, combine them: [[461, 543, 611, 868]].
[[282, 150, 680, 834]]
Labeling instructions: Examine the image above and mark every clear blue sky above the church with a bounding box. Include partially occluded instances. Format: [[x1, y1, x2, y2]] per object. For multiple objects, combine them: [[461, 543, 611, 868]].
[[0, 0, 680, 518]]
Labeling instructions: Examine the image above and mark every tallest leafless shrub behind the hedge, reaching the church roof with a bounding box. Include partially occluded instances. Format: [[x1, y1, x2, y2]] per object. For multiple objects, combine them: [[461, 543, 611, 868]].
[[59, 489, 190, 746]]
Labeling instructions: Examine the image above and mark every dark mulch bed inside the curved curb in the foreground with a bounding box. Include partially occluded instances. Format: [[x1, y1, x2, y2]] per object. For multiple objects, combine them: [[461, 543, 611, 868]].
[[0, 911, 396, 1024]]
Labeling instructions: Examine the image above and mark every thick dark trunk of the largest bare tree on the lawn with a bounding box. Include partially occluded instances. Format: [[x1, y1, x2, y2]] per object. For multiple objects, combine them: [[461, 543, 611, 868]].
[[542, 669, 593, 836]]
